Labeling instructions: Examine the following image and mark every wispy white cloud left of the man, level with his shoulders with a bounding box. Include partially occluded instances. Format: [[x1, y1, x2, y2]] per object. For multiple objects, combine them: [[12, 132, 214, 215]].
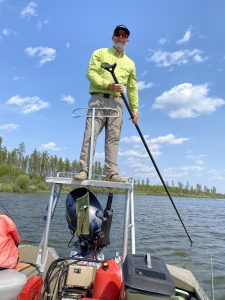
[[25, 47, 56, 65]]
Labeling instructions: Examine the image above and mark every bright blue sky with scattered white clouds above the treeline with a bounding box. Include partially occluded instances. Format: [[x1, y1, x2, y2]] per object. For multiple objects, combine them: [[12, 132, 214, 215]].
[[0, 0, 225, 193]]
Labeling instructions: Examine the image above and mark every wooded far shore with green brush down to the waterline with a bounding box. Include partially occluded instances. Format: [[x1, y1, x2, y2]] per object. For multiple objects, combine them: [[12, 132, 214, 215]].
[[0, 136, 225, 199]]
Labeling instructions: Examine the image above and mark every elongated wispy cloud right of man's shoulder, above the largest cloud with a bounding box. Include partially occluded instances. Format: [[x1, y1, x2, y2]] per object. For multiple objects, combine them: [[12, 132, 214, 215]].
[[147, 49, 207, 68]]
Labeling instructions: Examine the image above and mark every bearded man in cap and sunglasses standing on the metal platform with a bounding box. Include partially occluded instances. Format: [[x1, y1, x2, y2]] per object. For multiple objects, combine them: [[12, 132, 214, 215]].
[[74, 25, 138, 182]]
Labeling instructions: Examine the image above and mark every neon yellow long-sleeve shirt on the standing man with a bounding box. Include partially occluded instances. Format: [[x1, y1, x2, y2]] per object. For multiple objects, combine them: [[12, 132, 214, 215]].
[[87, 48, 138, 112]]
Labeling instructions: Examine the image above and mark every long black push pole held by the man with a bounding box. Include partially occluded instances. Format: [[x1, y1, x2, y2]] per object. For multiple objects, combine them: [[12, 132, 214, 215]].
[[102, 64, 193, 245]]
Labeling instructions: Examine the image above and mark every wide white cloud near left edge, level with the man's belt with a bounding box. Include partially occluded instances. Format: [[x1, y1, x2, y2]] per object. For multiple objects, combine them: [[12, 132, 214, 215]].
[[6, 95, 50, 114]]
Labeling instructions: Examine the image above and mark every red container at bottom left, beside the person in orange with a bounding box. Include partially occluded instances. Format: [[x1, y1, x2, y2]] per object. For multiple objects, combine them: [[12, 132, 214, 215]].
[[17, 276, 43, 300]]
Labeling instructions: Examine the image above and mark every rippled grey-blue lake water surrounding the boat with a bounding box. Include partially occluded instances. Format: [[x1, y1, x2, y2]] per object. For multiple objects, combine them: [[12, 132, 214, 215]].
[[0, 193, 225, 300]]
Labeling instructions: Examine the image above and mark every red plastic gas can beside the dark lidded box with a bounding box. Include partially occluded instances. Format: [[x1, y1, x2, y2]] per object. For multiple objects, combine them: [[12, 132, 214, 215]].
[[93, 259, 122, 300]]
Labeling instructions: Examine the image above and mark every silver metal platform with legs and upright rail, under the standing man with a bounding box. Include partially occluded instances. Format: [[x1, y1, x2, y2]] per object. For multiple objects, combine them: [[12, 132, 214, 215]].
[[36, 108, 136, 272]]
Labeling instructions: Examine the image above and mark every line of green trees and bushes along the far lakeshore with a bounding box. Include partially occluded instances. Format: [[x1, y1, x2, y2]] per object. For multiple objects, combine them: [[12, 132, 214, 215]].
[[0, 136, 223, 197]]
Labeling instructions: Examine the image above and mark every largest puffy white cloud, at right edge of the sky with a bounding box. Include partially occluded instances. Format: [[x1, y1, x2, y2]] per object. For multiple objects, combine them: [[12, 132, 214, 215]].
[[152, 83, 225, 119]]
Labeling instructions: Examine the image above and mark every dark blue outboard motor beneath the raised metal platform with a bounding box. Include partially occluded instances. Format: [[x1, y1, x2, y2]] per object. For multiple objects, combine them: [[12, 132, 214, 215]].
[[66, 187, 113, 257]]
